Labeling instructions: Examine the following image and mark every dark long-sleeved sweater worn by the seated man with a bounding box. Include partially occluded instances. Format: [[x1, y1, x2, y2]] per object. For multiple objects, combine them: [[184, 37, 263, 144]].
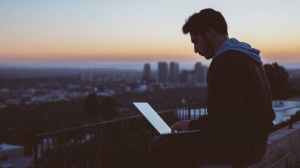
[[189, 51, 276, 144]]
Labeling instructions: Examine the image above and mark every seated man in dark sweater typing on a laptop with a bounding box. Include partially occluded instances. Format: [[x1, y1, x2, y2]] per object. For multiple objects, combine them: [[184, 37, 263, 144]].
[[150, 9, 275, 168]]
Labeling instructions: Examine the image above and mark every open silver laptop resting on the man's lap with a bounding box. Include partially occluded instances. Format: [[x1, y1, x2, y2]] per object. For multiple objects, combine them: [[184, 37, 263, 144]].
[[133, 102, 200, 135]]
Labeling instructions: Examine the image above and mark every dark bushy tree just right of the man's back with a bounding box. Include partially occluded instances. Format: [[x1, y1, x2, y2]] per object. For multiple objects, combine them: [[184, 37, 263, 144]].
[[264, 62, 289, 100]]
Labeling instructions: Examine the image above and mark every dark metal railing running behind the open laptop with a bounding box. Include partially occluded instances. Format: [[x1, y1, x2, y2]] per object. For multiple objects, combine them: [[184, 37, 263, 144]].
[[34, 108, 207, 168]]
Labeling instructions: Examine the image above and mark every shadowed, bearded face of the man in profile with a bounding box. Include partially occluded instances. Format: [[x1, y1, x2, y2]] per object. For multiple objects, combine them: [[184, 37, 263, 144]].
[[190, 33, 215, 60]]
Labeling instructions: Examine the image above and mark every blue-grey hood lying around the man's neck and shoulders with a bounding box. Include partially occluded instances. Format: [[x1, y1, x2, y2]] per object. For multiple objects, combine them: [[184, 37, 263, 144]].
[[213, 38, 263, 64]]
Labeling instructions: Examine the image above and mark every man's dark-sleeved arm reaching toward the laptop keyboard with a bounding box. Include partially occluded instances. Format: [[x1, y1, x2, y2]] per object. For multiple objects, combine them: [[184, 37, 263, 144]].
[[188, 69, 247, 130]]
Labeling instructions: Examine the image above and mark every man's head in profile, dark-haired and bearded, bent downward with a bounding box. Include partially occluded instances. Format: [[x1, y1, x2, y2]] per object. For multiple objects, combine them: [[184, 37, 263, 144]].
[[182, 9, 228, 59]]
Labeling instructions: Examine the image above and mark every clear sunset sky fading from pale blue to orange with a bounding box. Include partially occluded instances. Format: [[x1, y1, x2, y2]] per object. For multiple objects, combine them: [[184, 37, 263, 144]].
[[0, 0, 300, 67]]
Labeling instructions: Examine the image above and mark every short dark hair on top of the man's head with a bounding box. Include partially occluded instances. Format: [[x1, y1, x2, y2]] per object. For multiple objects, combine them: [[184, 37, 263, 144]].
[[182, 8, 228, 35]]
